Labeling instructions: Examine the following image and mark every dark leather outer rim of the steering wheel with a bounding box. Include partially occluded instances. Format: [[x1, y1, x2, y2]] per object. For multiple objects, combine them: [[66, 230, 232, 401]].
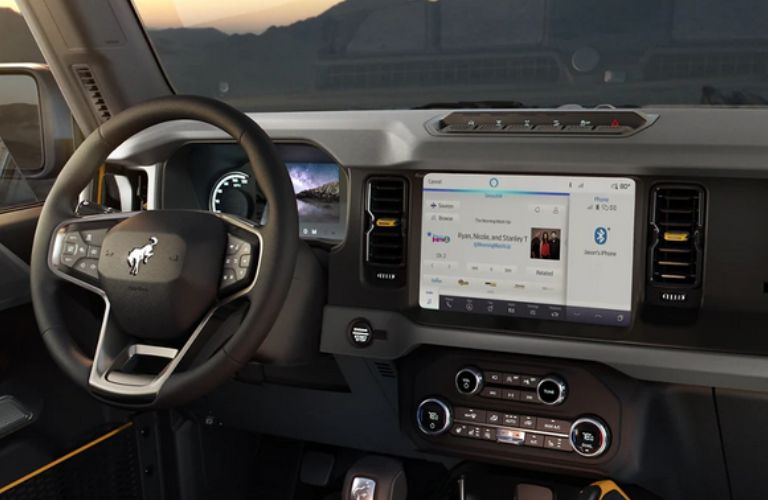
[[30, 96, 299, 407]]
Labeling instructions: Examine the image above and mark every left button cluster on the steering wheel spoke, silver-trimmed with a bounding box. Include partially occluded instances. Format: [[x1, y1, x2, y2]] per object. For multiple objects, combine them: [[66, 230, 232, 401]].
[[48, 213, 132, 292]]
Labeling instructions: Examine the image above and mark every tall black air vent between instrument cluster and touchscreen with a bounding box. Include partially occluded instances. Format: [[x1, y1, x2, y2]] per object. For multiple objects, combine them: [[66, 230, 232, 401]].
[[365, 177, 408, 286]]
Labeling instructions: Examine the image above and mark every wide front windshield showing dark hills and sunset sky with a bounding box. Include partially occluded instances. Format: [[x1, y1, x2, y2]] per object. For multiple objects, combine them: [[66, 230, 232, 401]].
[[134, 0, 768, 111]]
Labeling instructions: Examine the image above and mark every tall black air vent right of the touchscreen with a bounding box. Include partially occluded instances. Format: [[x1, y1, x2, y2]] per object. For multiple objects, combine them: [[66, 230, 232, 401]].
[[648, 185, 705, 307]]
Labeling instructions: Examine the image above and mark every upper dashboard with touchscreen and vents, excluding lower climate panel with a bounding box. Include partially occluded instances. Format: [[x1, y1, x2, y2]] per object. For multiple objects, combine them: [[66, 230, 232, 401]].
[[110, 107, 768, 364]]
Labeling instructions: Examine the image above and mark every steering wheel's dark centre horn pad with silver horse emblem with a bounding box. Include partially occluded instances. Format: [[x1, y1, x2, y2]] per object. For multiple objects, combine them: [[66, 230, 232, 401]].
[[99, 210, 227, 339]]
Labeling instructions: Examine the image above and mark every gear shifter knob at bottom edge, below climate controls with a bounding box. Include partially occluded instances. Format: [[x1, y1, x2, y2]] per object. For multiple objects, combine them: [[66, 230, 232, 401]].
[[342, 455, 408, 500]]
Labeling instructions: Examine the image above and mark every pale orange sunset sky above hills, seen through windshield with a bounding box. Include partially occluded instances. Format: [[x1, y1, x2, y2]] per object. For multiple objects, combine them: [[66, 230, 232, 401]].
[[134, 0, 342, 33]]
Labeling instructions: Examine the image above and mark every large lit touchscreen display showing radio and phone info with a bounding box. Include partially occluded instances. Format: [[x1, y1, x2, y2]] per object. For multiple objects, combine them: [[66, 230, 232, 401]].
[[419, 174, 635, 326]]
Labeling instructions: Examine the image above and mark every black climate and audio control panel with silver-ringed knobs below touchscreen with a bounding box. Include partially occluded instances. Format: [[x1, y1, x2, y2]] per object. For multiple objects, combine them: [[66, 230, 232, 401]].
[[401, 349, 622, 470]]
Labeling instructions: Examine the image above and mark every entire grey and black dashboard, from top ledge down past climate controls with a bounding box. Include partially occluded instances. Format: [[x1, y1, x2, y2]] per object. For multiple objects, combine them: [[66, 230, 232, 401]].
[[105, 107, 768, 498]]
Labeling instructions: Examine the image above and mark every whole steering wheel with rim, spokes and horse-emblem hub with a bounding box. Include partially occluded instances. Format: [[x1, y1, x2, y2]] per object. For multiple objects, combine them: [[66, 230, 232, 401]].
[[31, 96, 299, 407]]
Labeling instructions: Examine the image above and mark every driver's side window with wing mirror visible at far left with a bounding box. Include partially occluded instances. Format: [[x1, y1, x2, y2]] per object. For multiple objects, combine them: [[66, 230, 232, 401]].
[[0, 0, 72, 211]]
